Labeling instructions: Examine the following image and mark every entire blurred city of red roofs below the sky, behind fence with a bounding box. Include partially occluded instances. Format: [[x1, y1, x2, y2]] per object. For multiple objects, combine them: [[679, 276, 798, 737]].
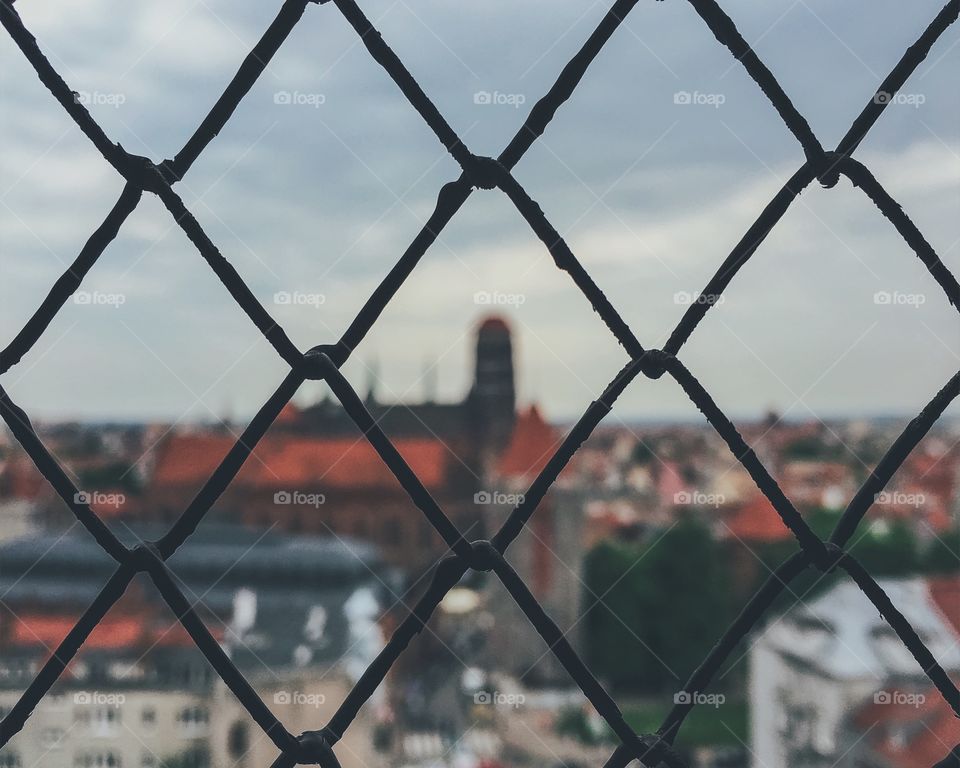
[[0, 317, 960, 768]]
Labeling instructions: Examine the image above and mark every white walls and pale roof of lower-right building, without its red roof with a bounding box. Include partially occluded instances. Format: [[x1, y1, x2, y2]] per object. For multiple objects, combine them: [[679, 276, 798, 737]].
[[749, 578, 960, 768]]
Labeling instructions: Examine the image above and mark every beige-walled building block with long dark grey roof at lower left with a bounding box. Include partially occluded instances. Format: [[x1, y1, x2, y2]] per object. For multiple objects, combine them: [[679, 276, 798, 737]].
[[0, 526, 391, 768]]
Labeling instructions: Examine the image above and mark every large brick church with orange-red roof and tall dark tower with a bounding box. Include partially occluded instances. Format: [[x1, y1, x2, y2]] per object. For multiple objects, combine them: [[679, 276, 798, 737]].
[[143, 317, 555, 572]]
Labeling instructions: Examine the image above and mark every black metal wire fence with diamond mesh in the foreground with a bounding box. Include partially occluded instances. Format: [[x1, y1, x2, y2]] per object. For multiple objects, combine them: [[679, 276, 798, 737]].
[[0, 0, 960, 768]]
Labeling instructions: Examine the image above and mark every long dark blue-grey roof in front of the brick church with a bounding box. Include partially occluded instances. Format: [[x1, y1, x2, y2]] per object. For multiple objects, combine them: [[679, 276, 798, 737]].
[[0, 525, 395, 673]]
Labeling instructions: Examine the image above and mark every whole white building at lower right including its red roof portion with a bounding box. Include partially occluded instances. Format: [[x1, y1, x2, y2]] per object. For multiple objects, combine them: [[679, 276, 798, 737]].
[[749, 577, 960, 768]]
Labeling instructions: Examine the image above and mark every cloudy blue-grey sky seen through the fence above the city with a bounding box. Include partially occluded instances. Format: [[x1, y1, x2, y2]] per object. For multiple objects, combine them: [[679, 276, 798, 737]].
[[0, 0, 960, 420]]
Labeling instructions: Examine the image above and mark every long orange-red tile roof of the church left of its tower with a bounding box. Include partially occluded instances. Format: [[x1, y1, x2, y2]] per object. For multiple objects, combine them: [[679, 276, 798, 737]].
[[152, 434, 449, 489]]
